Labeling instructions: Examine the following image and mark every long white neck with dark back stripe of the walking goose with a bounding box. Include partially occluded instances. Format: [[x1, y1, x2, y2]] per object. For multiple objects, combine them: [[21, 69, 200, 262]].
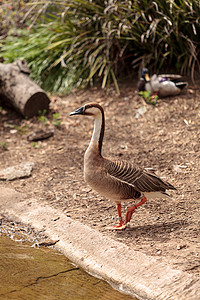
[[88, 111, 105, 155]]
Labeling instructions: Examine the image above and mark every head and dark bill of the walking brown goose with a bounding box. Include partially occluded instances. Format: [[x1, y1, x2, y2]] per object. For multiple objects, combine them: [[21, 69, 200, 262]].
[[69, 103, 103, 117]]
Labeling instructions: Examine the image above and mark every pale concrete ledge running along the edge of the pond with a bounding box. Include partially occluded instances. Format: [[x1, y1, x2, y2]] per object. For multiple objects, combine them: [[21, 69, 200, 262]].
[[0, 187, 200, 300]]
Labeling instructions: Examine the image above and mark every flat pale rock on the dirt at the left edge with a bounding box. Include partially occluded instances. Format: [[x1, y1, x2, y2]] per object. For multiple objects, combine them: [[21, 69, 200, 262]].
[[0, 162, 34, 180]]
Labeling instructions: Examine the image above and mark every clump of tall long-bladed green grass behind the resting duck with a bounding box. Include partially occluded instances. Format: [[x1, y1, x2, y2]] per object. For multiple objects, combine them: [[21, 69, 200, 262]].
[[2, 0, 200, 92]]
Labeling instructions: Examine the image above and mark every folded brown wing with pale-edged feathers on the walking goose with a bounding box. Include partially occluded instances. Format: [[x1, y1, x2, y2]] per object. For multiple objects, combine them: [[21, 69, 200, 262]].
[[107, 161, 175, 192]]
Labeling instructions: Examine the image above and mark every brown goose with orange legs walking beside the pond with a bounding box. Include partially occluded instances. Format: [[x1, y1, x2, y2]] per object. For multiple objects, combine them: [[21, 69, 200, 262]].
[[69, 103, 175, 230]]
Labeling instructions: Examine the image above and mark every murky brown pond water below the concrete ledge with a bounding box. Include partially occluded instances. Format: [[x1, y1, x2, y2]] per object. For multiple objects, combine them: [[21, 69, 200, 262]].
[[0, 235, 136, 300]]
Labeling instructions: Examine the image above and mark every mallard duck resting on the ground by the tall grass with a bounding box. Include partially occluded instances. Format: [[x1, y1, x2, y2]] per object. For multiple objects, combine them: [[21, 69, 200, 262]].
[[138, 68, 188, 98]]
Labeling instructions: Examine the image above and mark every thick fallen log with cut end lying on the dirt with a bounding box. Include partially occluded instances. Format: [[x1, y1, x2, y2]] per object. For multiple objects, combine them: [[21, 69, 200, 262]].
[[0, 60, 50, 117]]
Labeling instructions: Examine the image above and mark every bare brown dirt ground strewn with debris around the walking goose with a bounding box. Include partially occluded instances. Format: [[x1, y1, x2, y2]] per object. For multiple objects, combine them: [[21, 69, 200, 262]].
[[0, 83, 200, 273]]
